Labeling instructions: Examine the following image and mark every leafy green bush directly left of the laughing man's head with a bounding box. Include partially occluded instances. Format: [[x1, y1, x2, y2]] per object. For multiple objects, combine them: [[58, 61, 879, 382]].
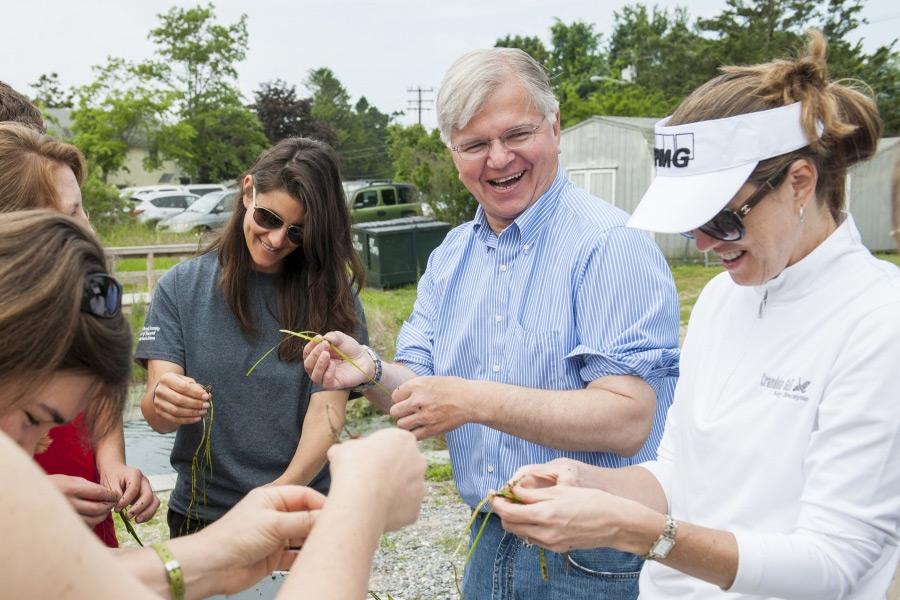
[[388, 124, 478, 226]]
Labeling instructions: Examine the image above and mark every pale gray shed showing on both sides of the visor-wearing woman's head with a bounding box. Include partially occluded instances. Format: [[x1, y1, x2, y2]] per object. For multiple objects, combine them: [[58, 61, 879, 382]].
[[560, 116, 900, 260]]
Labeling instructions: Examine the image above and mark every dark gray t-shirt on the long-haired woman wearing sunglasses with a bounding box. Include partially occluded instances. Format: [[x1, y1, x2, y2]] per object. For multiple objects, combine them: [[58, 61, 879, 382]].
[[135, 253, 368, 522]]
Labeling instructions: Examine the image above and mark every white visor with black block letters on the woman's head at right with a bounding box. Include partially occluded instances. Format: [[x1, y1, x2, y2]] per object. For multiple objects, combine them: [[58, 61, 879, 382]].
[[628, 102, 821, 233]]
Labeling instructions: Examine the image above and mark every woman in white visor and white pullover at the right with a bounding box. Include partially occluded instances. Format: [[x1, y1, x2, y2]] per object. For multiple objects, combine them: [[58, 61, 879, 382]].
[[493, 32, 900, 600]]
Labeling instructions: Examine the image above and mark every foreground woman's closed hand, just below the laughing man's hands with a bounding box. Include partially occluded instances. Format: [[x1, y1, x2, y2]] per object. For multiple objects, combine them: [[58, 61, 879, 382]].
[[328, 428, 427, 532]]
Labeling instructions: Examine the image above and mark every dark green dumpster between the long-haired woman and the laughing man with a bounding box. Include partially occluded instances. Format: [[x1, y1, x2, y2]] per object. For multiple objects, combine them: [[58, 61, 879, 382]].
[[353, 217, 450, 289]]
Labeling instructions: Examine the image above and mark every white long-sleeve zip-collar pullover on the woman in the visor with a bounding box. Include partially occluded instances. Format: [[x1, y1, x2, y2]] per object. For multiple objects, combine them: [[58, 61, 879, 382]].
[[641, 215, 900, 600]]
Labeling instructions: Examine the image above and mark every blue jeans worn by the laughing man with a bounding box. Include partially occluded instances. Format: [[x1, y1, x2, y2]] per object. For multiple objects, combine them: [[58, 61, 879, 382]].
[[462, 514, 644, 600]]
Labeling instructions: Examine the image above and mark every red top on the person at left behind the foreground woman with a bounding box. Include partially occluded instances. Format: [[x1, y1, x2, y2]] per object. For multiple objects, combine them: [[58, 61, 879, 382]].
[[34, 413, 119, 548]]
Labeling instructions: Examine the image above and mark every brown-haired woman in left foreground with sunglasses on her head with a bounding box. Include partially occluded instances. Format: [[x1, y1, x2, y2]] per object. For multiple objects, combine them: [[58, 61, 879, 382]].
[[0, 211, 425, 600]]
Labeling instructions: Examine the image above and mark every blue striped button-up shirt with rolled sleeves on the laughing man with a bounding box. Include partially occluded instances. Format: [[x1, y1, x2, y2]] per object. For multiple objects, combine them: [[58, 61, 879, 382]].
[[395, 169, 679, 507]]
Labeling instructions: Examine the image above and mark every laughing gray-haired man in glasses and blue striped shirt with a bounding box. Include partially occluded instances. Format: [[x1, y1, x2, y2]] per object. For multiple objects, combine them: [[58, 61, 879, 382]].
[[306, 48, 679, 600]]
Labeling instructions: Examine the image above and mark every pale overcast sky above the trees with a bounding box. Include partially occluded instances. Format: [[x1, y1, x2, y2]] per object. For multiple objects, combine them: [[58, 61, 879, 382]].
[[0, 0, 900, 127]]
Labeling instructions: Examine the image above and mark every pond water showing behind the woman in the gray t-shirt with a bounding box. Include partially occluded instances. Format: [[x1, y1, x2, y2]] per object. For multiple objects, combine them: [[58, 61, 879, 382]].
[[124, 384, 447, 476]]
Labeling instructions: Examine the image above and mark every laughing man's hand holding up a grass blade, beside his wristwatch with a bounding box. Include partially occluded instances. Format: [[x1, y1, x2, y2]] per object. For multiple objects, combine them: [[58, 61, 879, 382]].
[[303, 331, 375, 390]]
